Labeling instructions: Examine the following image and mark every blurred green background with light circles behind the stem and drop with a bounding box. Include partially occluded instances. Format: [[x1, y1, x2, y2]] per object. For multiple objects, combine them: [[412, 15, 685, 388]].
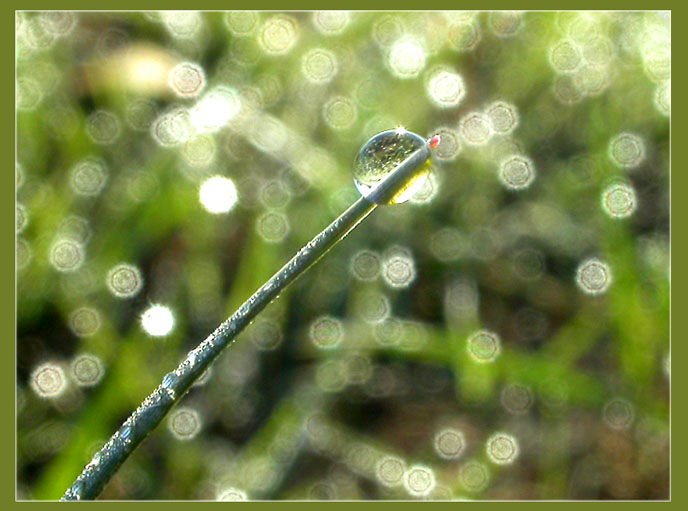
[[16, 11, 671, 500]]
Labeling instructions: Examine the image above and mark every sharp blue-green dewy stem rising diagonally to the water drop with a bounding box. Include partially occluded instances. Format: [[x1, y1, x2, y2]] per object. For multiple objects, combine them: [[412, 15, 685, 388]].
[[61, 138, 430, 500]]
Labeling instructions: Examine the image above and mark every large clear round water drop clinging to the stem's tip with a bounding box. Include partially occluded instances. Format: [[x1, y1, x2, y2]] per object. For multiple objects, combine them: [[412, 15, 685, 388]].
[[354, 128, 439, 204]]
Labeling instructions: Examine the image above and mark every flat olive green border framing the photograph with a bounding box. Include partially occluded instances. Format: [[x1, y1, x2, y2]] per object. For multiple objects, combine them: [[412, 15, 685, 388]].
[[5, 0, 688, 509]]
